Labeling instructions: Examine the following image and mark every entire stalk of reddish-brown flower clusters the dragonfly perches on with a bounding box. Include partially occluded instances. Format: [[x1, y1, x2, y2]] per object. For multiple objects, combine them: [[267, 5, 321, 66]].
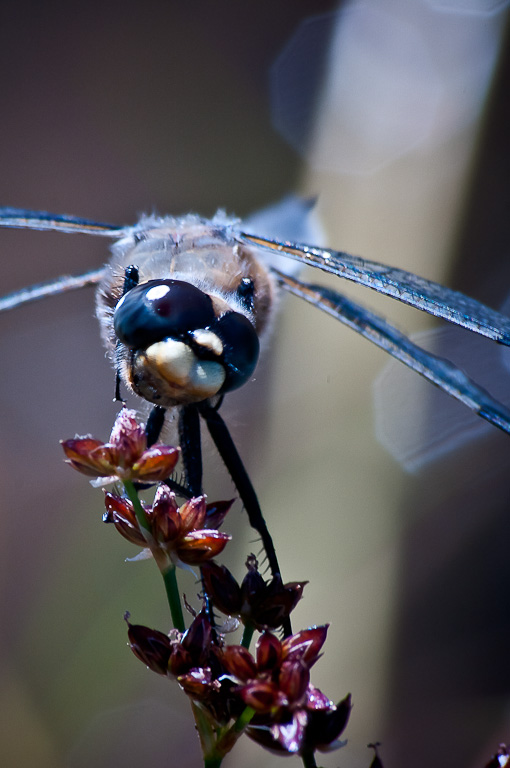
[[62, 408, 356, 768]]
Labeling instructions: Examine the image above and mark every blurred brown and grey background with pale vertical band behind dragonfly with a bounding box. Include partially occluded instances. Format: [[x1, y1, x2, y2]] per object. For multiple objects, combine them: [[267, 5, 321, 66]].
[[0, 0, 510, 768]]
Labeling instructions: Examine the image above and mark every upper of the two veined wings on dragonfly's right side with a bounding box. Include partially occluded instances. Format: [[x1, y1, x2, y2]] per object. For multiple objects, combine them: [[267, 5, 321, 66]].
[[239, 232, 510, 345]]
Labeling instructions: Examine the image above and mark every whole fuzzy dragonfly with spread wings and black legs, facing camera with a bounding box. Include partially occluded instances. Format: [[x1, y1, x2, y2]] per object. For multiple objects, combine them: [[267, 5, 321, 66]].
[[0, 204, 510, 574]]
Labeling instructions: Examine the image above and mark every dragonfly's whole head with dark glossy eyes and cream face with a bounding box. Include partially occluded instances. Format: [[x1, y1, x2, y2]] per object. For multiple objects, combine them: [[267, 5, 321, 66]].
[[113, 279, 259, 406]]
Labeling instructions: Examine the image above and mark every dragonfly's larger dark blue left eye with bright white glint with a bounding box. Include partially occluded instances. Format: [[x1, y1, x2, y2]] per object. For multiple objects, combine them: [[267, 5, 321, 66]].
[[113, 280, 215, 349]]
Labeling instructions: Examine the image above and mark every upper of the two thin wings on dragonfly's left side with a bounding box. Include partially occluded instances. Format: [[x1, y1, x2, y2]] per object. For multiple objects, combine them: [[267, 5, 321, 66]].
[[0, 207, 125, 237]]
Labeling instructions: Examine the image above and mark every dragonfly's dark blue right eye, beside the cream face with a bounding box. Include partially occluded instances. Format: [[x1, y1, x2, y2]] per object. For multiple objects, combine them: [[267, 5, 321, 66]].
[[211, 312, 260, 392]]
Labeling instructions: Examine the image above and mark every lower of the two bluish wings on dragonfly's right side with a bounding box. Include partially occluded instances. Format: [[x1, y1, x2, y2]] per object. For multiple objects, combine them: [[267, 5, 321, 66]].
[[274, 270, 510, 433]]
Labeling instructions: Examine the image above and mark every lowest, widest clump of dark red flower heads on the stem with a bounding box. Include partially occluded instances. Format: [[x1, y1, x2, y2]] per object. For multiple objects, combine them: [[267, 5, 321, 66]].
[[128, 611, 351, 754]]
